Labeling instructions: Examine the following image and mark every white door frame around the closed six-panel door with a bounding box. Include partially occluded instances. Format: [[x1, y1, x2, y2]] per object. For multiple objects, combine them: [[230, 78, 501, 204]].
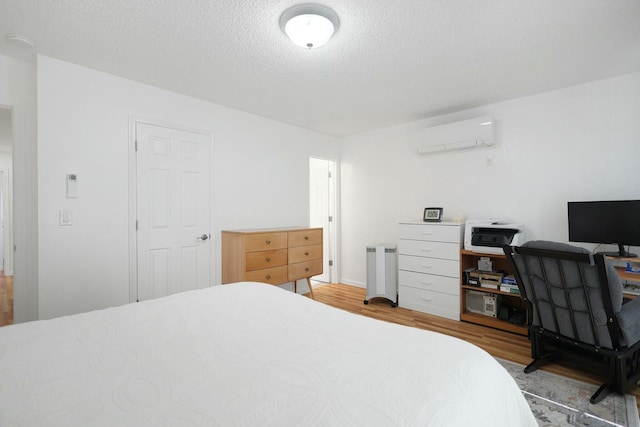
[[128, 115, 216, 302]]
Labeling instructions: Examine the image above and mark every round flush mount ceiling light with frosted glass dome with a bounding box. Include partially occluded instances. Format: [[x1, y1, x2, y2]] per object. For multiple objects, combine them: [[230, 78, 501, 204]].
[[280, 4, 340, 49]]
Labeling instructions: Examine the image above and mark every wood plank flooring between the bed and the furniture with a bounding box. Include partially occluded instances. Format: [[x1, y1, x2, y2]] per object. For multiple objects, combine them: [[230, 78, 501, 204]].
[[313, 284, 640, 410]]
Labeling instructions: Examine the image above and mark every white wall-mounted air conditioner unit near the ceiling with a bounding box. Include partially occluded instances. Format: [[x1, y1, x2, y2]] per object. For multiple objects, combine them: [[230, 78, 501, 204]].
[[412, 117, 496, 154]]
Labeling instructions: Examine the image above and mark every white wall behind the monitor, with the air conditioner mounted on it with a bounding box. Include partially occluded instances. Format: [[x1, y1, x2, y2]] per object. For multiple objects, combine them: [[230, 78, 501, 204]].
[[341, 73, 640, 286]]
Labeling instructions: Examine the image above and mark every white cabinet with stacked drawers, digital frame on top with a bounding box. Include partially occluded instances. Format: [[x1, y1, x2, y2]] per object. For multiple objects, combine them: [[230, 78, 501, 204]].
[[398, 221, 464, 320]]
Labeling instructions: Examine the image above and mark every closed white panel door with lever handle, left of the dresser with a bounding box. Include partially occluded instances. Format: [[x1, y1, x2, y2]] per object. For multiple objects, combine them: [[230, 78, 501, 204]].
[[136, 123, 211, 301]]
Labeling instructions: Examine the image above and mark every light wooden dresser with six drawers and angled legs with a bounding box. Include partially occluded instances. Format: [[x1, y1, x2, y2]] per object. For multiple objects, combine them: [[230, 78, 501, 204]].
[[222, 228, 323, 298]]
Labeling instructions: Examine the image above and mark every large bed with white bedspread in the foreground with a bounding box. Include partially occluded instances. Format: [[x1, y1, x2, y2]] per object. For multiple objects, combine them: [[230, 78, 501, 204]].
[[0, 282, 536, 426]]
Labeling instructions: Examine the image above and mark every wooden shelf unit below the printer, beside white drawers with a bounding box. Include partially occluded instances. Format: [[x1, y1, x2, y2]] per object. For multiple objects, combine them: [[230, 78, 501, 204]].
[[460, 249, 530, 336]]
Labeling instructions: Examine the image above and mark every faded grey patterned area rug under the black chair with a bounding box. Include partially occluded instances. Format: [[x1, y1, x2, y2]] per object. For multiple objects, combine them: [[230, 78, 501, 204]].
[[496, 358, 640, 427]]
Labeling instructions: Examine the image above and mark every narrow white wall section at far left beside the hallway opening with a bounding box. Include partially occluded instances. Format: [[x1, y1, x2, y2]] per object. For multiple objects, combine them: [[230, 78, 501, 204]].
[[0, 55, 38, 322]]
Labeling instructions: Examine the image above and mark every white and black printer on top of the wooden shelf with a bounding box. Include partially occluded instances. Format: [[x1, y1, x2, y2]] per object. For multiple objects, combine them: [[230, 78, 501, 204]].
[[464, 219, 524, 254]]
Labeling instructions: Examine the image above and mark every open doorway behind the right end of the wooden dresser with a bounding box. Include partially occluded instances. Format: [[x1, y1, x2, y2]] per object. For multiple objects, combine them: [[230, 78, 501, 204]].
[[309, 157, 337, 283]]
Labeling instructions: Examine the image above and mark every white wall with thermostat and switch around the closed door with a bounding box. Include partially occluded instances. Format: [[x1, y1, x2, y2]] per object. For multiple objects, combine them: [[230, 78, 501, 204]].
[[37, 56, 338, 318]]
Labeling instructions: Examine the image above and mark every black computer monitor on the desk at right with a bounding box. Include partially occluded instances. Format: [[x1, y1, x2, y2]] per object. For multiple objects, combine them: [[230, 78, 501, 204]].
[[567, 200, 640, 257]]
